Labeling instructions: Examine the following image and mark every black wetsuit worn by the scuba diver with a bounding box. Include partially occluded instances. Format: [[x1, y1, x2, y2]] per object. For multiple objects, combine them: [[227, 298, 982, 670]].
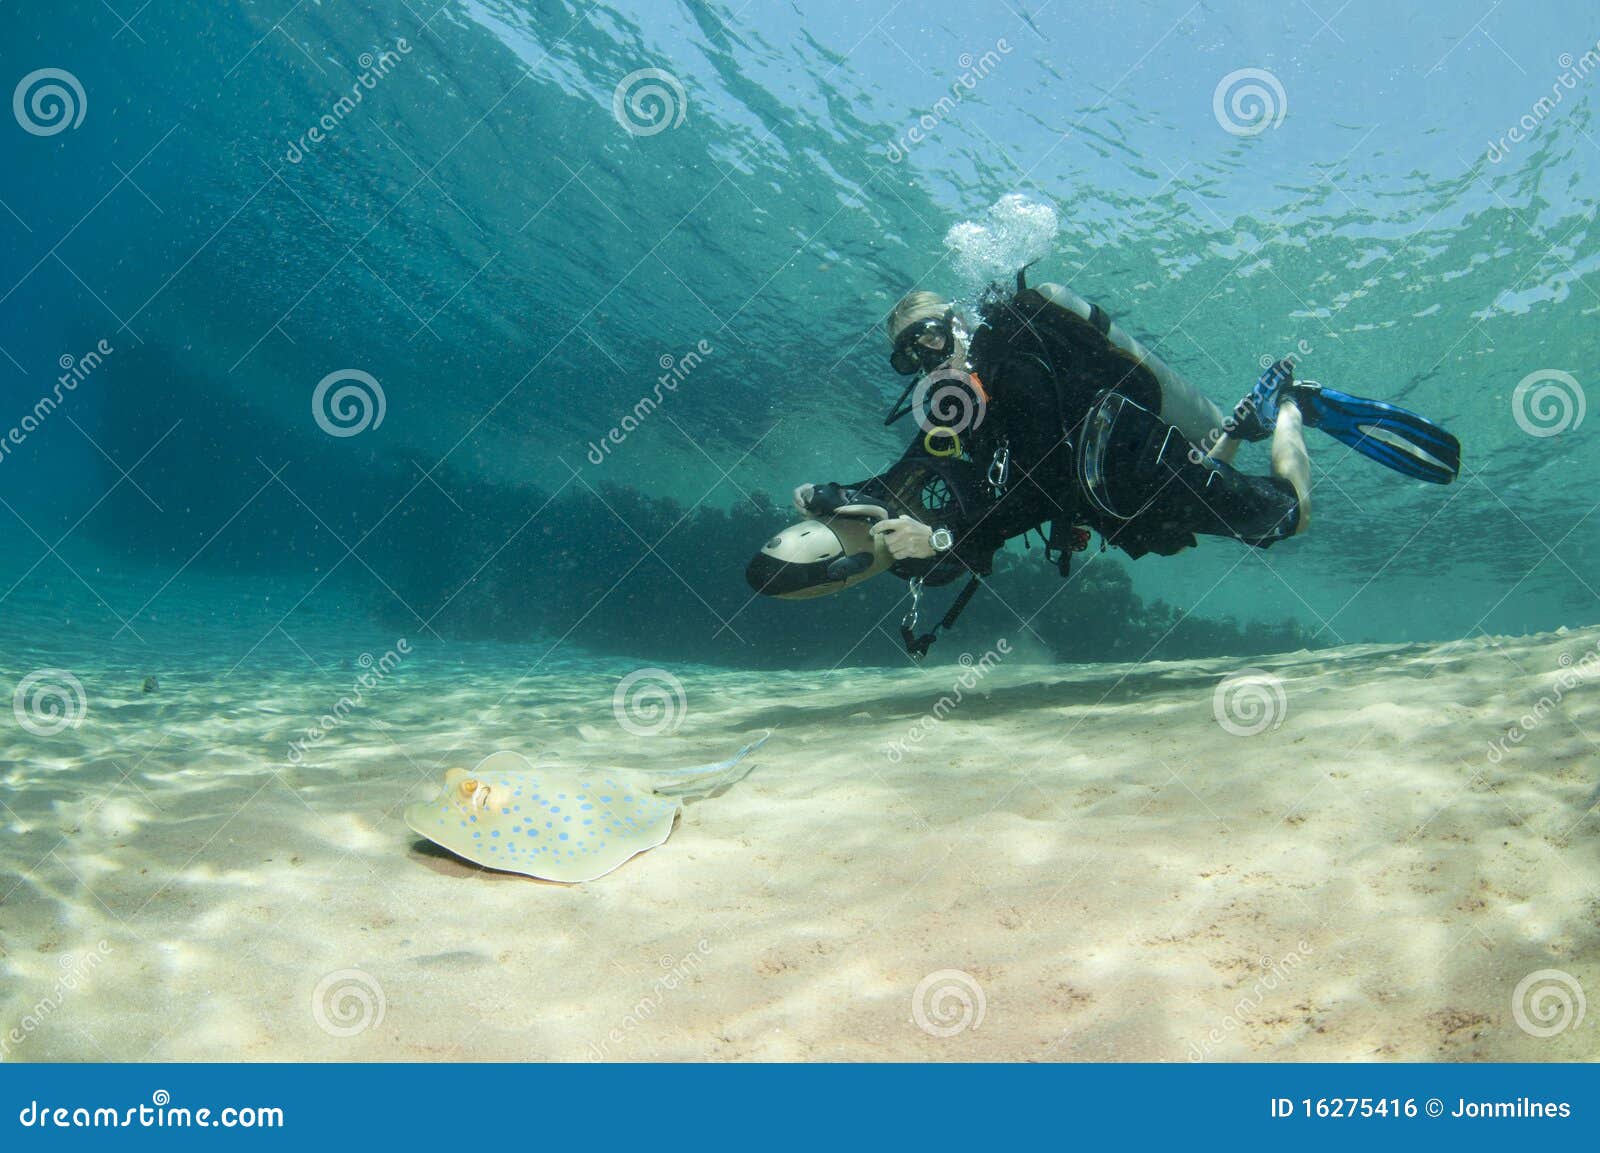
[[851, 288, 1298, 584]]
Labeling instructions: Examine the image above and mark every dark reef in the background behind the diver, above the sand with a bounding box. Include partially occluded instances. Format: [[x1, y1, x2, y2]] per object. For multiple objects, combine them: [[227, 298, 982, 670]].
[[85, 349, 1310, 668]]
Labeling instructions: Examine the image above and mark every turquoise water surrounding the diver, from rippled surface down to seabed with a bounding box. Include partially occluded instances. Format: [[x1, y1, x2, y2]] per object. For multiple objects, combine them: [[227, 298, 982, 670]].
[[0, 3, 1600, 664]]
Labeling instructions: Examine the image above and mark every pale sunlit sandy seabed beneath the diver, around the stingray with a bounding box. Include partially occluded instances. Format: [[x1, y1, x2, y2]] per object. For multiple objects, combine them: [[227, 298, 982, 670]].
[[0, 630, 1600, 1060]]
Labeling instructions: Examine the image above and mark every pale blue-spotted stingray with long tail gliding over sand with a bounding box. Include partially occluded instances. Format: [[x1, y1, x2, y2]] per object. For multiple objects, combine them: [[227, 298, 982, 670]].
[[405, 732, 771, 883]]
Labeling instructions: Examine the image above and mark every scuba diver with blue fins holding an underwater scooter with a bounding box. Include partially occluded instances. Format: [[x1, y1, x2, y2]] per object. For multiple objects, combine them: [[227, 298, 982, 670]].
[[746, 269, 1461, 659]]
